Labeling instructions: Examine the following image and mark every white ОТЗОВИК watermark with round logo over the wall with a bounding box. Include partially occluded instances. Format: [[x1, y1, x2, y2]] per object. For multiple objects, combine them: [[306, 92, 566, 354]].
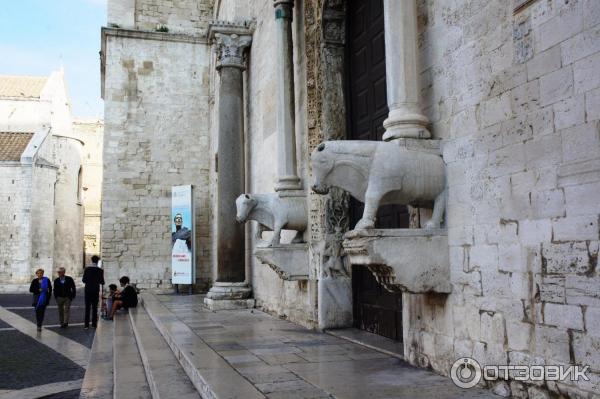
[[450, 357, 590, 388]]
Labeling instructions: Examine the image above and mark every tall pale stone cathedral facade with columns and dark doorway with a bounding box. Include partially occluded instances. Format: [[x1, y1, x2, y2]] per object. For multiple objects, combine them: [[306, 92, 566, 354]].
[[101, 0, 600, 397]]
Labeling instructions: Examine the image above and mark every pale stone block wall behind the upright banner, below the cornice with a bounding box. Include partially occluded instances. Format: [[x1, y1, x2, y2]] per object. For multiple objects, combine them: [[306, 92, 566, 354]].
[[101, 34, 212, 289]]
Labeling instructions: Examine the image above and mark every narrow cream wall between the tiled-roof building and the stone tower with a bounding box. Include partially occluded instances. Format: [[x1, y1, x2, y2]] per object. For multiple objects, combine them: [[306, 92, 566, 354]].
[[73, 119, 104, 266]]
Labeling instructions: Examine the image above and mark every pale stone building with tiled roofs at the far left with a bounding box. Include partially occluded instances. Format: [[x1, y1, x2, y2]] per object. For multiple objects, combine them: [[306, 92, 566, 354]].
[[0, 70, 83, 284]]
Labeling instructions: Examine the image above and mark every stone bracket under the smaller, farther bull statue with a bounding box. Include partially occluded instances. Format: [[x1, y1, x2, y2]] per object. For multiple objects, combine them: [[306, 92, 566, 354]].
[[254, 243, 309, 281]]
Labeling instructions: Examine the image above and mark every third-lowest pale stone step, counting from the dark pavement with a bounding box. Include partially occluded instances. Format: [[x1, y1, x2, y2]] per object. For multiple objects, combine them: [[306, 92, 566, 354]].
[[129, 307, 200, 399]]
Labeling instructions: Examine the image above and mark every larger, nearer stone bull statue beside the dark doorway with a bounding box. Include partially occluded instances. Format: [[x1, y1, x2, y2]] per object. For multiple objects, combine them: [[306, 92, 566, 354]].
[[311, 140, 446, 230]]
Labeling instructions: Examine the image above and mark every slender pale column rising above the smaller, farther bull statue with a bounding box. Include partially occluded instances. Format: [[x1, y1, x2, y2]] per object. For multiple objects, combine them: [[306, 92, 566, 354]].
[[274, 0, 301, 191]]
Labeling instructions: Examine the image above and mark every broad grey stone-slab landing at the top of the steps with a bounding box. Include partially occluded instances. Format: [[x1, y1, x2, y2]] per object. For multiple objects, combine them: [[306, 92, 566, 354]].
[[142, 293, 496, 399]]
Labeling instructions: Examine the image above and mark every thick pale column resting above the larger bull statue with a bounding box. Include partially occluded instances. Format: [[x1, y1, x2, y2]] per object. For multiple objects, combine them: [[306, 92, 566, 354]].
[[383, 0, 431, 141]]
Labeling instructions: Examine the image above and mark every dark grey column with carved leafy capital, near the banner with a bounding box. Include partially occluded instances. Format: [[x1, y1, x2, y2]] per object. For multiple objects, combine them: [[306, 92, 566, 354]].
[[205, 28, 252, 309]]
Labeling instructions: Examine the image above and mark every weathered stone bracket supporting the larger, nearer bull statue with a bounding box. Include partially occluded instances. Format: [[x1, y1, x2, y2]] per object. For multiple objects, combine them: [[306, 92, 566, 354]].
[[343, 229, 452, 294]]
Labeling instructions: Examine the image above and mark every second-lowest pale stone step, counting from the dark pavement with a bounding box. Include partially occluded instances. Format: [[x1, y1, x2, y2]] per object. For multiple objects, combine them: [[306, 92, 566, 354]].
[[113, 313, 152, 399]]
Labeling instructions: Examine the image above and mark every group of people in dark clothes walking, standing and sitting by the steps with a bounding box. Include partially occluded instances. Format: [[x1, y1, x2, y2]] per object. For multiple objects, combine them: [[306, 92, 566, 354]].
[[29, 255, 138, 331]]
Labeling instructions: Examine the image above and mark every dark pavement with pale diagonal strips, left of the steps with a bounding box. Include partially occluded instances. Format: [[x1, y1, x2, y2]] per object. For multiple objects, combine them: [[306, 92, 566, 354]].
[[0, 294, 94, 399]]
